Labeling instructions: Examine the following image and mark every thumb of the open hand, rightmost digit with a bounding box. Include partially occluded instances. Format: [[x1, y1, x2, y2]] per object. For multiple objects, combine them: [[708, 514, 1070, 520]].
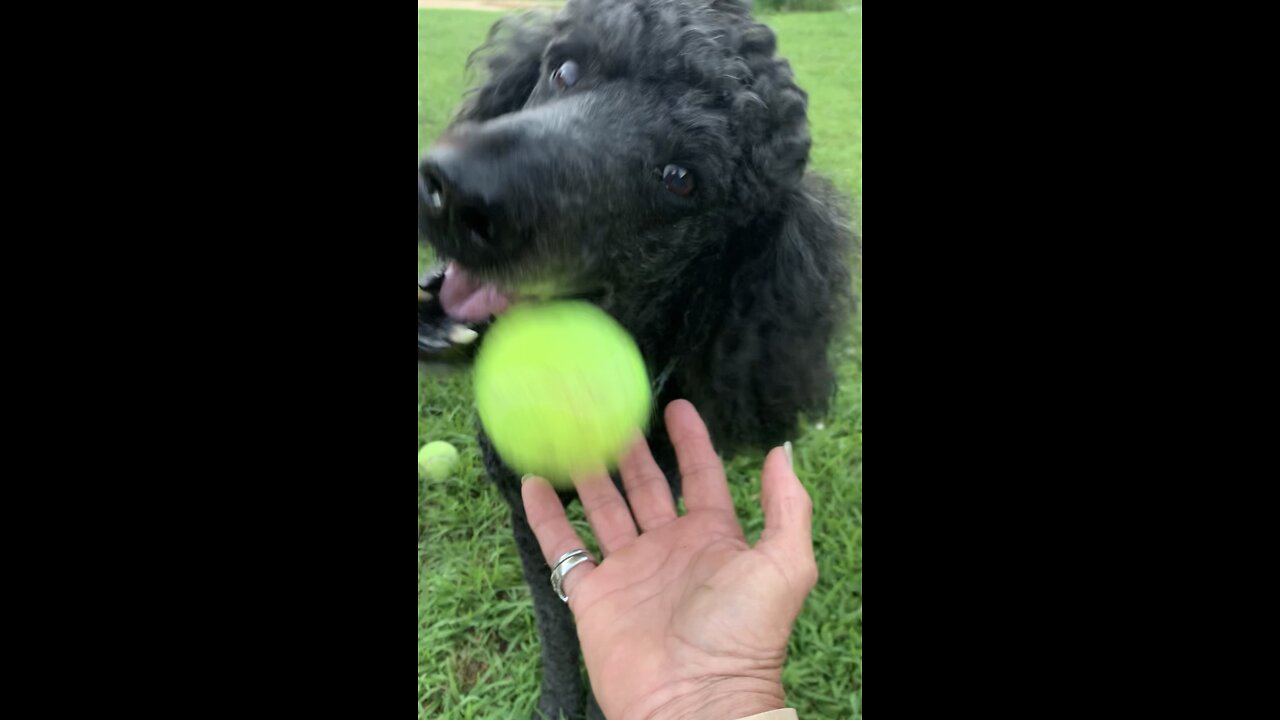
[[758, 447, 818, 589]]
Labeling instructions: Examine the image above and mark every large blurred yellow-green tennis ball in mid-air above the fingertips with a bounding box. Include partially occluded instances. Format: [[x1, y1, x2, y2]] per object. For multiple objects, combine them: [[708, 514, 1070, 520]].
[[475, 301, 652, 487]]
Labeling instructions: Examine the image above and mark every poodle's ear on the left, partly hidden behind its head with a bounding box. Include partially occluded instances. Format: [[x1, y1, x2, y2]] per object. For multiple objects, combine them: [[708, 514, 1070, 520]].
[[454, 10, 552, 122]]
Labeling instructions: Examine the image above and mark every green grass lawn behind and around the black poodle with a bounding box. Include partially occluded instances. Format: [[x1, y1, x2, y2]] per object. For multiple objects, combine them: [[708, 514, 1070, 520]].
[[417, 10, 863, 720]]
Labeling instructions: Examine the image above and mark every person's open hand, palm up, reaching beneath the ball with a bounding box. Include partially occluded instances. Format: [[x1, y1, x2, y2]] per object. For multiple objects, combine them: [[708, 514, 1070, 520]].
[[525, 401, 817, 720]]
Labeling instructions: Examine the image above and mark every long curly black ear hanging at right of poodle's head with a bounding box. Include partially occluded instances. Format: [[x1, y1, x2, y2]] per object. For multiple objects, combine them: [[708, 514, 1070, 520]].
[[681, 178, 855, 450]]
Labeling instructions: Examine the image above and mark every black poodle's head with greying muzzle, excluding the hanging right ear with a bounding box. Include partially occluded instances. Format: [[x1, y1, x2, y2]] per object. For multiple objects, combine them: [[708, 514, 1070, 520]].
[[417, 0, 809, 320]]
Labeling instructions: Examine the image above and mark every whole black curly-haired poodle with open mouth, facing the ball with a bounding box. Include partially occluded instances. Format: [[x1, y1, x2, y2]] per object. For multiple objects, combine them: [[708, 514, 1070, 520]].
[[417, 0, 854, 719]]
